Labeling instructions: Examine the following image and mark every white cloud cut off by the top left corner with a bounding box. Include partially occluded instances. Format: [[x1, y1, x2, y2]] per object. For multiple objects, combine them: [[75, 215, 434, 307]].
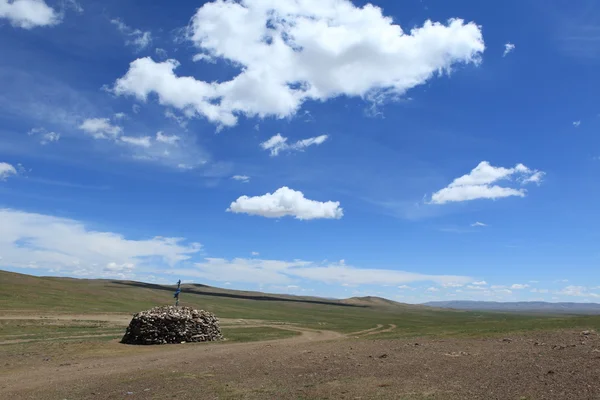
[[0, 0, 61, 29]]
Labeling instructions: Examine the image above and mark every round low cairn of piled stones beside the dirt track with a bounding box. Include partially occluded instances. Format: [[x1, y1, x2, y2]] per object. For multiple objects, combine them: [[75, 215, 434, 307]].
[[121, 306, 223, 344]]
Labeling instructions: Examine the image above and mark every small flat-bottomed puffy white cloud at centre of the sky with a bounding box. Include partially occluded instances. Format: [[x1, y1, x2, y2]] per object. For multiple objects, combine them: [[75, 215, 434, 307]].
[[227, 186, 344, 220]]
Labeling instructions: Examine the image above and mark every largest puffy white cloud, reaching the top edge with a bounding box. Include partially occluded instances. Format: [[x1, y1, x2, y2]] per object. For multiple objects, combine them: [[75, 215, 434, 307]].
[[114, 0, 485, 126]]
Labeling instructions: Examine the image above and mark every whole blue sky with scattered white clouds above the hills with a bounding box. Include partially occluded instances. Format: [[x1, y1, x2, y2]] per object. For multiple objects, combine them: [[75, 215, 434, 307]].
[[0, 0, 600, 302]]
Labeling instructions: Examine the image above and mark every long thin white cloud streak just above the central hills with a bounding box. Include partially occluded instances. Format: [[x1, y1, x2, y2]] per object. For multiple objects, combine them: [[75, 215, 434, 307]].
[[172, 258, 472, 285]]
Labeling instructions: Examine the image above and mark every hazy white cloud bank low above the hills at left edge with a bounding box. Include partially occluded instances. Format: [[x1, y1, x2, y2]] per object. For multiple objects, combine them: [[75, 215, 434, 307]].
[[0, 209, 201, 278]]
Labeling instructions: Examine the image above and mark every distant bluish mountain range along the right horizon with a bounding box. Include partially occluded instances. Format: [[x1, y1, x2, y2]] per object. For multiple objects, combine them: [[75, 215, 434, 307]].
[[423, 300, 600, 315]]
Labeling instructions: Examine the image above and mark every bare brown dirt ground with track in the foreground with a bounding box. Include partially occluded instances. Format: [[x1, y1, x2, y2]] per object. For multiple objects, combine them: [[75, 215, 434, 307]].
[[0, 316, 600, 400]]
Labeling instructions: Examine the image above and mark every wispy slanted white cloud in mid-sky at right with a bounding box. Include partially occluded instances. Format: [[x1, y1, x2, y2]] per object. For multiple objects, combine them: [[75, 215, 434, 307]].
[[431, 161, 544, 204]]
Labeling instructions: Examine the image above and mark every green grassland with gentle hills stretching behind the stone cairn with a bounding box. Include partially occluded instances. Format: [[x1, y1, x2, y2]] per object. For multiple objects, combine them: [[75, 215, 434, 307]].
[[0, 271, 600, 340]]
